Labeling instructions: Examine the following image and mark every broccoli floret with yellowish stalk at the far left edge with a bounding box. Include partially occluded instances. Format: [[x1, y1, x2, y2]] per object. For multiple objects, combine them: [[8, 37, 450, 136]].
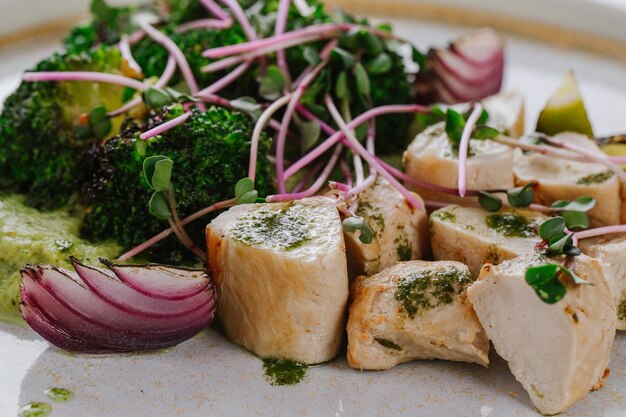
[[0, 47, 132, 209]]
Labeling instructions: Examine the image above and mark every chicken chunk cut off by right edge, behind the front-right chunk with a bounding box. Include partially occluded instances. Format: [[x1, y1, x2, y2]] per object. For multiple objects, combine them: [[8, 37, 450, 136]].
[[579, 234, 626, 330]]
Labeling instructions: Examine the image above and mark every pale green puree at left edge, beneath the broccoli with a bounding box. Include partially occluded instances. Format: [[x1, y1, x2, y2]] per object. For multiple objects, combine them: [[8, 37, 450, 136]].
[[0, 195, 121, 322]]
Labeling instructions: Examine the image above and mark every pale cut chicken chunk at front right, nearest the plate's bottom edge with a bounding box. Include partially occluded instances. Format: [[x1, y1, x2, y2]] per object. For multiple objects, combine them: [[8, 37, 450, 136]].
[[467, 254, 615, 414]]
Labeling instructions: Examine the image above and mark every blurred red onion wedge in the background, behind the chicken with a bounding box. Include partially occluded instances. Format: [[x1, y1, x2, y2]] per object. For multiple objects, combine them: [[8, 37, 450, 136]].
[[416, 29, 504, 104]]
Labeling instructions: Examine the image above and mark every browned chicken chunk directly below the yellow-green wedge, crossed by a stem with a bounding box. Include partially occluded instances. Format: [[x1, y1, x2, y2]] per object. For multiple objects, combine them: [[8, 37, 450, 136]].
[[513, 133, 621, 227]]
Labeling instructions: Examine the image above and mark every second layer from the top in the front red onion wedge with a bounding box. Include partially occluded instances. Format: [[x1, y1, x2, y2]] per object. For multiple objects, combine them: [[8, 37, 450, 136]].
[[70, 257, 208, 318]]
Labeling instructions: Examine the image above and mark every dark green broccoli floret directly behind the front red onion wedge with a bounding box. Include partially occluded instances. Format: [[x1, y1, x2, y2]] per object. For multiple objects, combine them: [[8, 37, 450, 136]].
[[83, 105, 273, 262]]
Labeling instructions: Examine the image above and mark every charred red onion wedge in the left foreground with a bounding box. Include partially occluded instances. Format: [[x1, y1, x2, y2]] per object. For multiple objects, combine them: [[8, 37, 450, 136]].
[[20, 258, 215, 353]]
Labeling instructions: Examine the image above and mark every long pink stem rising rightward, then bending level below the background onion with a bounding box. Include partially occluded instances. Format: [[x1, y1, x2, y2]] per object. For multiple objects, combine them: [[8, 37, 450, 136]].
[[285, 104, 431, 178]]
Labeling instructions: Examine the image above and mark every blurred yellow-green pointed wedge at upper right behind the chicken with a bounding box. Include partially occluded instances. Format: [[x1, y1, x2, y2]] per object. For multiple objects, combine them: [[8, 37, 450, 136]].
[[536, 71, 594, 137]]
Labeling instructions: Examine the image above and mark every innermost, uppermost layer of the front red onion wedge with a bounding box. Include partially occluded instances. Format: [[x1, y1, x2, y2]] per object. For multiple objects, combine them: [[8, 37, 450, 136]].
[[101, 259, 207, 300]]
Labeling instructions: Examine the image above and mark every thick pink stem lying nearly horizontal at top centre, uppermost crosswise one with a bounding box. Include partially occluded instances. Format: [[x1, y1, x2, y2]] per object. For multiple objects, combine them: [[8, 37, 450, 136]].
[[202, 23, 358, 59]]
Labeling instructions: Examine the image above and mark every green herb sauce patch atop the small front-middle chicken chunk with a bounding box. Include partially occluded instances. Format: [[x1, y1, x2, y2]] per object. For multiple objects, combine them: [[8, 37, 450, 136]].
[[395, 267, 472, 318]]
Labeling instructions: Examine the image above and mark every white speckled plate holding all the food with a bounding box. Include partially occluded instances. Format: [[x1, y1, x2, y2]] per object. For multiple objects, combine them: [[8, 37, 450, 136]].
[[0, 8, 626, 417]]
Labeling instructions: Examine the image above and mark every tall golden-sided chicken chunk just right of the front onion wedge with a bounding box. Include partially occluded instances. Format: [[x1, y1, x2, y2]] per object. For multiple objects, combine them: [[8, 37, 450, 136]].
[[207, 197, 348, 364]]
